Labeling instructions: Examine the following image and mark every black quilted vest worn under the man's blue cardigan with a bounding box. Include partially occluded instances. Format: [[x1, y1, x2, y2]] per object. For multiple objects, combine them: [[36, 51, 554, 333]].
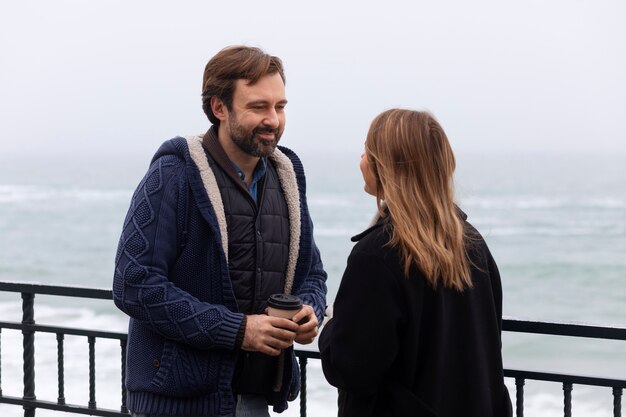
[[203, 129, 290, 395]]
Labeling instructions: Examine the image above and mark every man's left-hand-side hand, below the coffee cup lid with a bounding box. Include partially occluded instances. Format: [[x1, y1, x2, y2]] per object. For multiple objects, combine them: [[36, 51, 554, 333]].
[[241, 309, 298, 356]]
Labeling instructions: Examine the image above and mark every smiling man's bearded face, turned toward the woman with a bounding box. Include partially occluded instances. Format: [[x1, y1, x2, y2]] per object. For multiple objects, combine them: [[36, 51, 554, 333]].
[[225, 74, 287, 156]]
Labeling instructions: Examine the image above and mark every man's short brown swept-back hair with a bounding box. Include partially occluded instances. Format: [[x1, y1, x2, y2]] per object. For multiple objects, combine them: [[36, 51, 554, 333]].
[[202, 45, 285, 126]]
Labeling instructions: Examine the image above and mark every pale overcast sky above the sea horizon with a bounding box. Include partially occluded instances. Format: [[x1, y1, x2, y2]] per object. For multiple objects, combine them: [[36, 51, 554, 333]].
[[0, 0, 626, 156]]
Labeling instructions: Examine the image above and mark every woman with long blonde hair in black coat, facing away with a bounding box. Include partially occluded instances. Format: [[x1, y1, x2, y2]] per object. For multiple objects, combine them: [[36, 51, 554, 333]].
[[319, 109, 512, 417]]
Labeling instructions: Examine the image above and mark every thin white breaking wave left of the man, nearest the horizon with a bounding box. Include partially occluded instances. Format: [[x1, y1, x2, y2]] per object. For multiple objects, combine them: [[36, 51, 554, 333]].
[[0, 185, 132, 204]]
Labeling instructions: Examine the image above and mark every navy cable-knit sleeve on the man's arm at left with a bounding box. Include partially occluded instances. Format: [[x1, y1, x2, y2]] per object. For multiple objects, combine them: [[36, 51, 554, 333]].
[[113, 156, 243, 349]]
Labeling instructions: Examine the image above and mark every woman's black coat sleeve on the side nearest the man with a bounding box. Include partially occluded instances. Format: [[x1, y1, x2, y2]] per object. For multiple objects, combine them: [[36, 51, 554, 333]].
[[319, 251, 403, 395]]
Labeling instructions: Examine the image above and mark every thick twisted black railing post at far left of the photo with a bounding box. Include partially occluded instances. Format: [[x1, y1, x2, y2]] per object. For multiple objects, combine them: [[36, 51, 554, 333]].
[[22, 292, 37, 417]]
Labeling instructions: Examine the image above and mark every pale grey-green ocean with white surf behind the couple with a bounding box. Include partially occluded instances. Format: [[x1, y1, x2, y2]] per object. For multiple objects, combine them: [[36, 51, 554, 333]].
[[0, 148, 626, 417]]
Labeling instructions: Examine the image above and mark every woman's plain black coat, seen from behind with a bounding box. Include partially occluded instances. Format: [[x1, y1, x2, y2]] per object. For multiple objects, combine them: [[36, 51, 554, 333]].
[[319, 221, 512, 417]]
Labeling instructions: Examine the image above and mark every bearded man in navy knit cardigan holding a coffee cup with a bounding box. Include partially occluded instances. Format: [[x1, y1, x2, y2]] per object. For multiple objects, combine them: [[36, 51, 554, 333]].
[[113, 46, 326, 417]]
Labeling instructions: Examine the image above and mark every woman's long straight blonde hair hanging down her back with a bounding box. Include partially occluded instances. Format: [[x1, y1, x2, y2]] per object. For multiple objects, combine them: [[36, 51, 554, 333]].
[[365, 109, 472, 291]]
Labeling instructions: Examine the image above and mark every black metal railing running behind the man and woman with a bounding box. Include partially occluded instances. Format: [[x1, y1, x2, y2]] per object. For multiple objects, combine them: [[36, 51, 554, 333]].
[[0, 282, 626, 417]]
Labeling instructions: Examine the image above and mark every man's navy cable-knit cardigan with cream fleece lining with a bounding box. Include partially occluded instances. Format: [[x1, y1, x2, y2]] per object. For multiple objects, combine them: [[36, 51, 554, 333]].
[[113, 136, 326, 415]]
